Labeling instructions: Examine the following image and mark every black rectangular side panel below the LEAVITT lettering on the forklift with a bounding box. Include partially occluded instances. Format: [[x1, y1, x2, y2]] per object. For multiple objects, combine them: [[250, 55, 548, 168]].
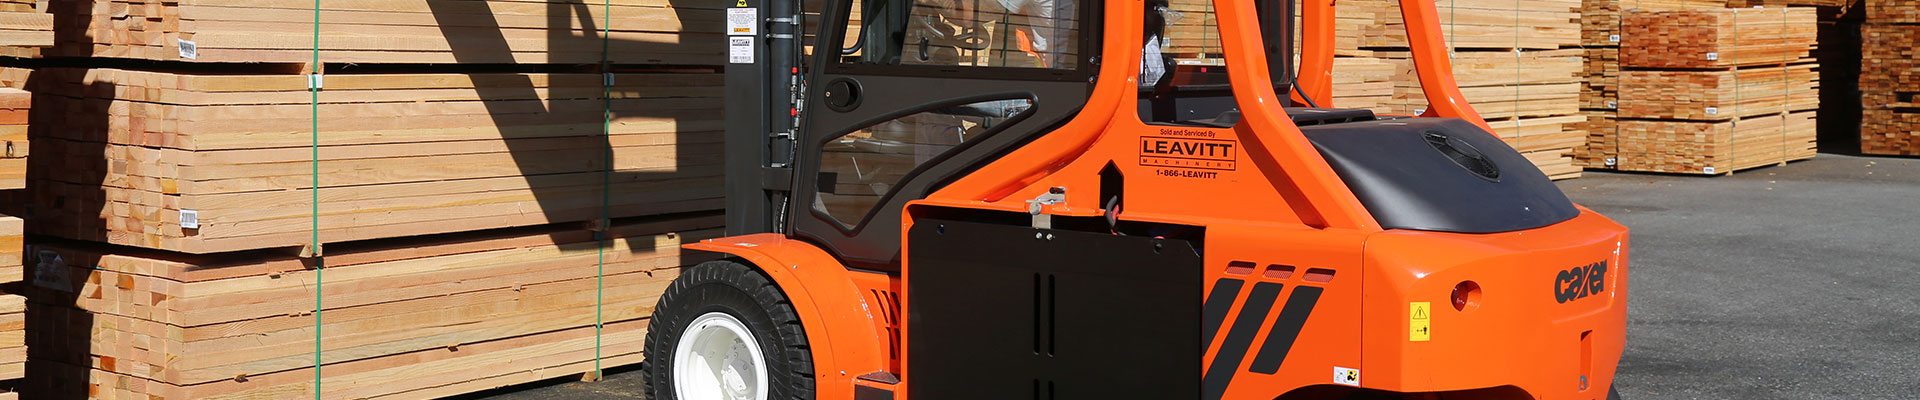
[[906, 219, 1204, 400]]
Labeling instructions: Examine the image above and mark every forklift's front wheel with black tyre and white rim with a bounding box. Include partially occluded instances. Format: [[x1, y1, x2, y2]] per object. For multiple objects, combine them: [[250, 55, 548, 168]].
[[641, 260, 814, 400]]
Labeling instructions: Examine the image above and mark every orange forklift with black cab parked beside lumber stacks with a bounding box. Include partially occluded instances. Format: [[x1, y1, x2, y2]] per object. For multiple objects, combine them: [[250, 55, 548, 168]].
[[641, 0, 1628, 400]]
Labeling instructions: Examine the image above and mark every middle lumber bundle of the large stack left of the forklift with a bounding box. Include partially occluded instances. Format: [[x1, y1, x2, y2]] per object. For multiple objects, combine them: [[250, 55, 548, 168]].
[[20, 69, 724, 254]]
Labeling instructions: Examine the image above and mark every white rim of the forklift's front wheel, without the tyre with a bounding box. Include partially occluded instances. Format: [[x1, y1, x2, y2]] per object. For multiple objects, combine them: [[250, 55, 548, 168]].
[[674, 312, 766, 400]]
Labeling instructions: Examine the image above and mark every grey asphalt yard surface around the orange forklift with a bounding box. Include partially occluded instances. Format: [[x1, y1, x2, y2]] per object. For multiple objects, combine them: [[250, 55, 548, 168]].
[[467, 154, 1920, 400]]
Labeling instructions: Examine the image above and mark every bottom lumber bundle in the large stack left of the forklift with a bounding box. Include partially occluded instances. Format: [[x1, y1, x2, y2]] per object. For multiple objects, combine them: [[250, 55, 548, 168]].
[[29, 213, 722, 400]]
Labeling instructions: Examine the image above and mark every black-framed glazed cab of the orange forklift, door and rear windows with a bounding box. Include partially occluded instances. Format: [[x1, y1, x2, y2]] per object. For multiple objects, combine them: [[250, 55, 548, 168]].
[[772, 0, 1397, 265]]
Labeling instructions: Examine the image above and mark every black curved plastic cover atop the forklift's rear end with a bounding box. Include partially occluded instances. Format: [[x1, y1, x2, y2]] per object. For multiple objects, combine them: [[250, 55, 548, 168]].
[[1300, 117, 1580, 233]]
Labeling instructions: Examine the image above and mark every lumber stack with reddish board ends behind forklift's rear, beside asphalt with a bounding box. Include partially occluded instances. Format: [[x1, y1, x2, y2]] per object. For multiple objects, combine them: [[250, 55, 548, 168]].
[[1613, 8, 1820, 175]]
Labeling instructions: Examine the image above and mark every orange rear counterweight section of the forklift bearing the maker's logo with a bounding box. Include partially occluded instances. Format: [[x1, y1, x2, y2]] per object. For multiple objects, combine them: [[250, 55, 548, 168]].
[[1363, 210, 1628, 400]]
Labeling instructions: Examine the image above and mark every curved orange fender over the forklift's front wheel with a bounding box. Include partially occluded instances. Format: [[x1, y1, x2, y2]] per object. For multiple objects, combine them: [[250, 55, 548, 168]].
[[684, 233, 889, 398]]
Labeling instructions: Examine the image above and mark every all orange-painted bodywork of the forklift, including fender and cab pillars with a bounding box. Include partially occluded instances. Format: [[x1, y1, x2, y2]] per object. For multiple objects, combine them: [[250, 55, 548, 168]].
[[689, 0, 1626, 400]]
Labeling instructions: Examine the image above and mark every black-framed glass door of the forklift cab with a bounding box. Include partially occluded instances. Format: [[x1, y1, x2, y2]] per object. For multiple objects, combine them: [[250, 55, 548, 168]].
[[787, 0, 1100, 271]]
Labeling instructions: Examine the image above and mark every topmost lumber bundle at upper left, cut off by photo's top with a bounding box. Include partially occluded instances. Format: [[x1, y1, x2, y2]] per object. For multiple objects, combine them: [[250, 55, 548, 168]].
[[48, 0, 730, 65]]
